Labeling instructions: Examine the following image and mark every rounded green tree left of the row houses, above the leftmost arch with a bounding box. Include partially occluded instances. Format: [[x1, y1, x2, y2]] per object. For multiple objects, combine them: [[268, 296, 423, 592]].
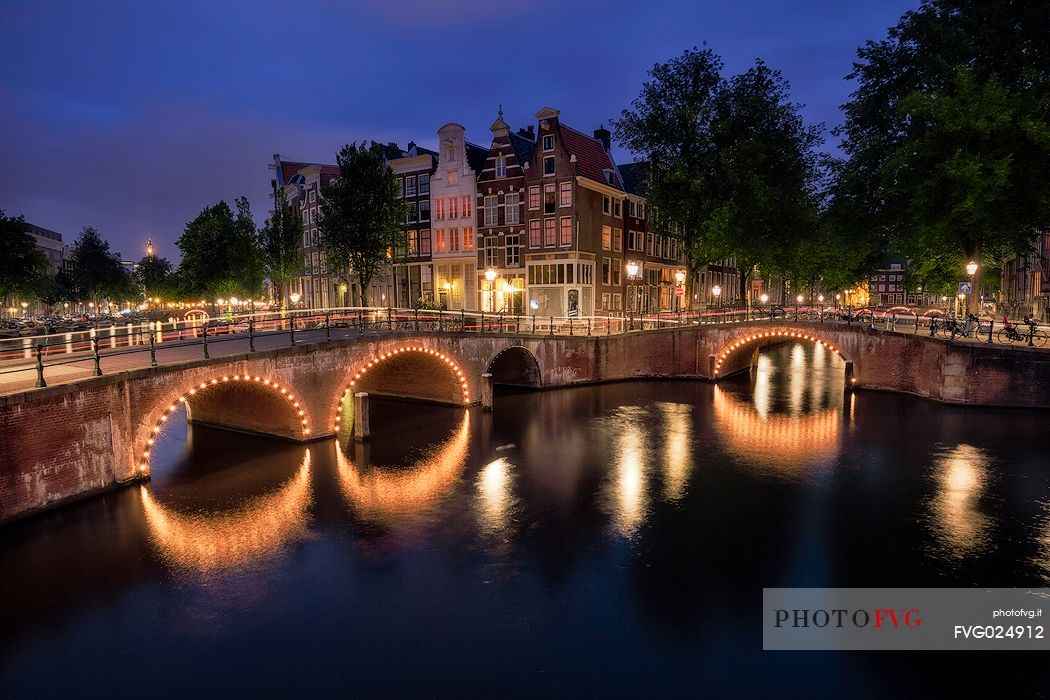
[[175, 197, 263, 299]]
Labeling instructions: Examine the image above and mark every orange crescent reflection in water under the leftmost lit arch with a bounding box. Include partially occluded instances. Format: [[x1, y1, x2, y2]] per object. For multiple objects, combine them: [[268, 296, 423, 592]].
[[139, 449, 310, 571]]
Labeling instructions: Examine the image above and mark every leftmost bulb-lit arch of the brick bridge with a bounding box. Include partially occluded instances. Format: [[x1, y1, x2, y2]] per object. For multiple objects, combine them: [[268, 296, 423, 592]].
[[134, 374, 311, 474]]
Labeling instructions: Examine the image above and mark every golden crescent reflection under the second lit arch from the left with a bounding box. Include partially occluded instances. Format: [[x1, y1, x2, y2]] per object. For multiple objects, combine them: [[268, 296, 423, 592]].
[[336, 412, 470, 521]]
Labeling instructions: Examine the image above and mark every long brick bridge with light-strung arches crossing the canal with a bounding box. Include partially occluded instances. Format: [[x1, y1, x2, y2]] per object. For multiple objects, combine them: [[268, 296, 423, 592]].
[[0, 321, 1050, 522]]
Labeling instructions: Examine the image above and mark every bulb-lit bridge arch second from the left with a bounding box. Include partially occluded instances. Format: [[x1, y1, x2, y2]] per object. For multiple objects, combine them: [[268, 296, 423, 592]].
[[330, 344, 470, 432]]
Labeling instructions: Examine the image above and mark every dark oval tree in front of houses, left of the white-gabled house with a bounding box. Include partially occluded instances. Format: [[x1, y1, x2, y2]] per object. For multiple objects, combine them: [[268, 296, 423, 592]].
[[318, 142, 408, 305]]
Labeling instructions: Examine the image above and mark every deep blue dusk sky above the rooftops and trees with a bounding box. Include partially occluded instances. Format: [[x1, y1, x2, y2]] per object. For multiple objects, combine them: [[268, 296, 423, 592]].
[[0, 0, 918, 259]]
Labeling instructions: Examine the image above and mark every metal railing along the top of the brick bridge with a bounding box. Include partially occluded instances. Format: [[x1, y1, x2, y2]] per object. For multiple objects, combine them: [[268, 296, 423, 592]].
[[0, 305, 1045, 387]]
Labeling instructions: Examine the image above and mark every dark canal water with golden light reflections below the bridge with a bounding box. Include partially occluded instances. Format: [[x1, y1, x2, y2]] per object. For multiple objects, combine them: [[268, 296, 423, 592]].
[[0, 344, 1050, 698]]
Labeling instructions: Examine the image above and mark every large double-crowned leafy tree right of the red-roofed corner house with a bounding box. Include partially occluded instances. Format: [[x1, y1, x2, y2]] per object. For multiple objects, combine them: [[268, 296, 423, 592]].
[[613, 48, 822, 306]]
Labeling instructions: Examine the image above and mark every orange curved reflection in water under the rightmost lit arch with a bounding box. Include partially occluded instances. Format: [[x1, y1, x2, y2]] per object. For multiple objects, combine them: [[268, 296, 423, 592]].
[[714, 385, 842, 470]]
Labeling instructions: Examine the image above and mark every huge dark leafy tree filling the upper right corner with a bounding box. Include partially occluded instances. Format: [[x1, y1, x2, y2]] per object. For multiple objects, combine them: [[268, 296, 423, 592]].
[[836, 0, 1050, 312]]
